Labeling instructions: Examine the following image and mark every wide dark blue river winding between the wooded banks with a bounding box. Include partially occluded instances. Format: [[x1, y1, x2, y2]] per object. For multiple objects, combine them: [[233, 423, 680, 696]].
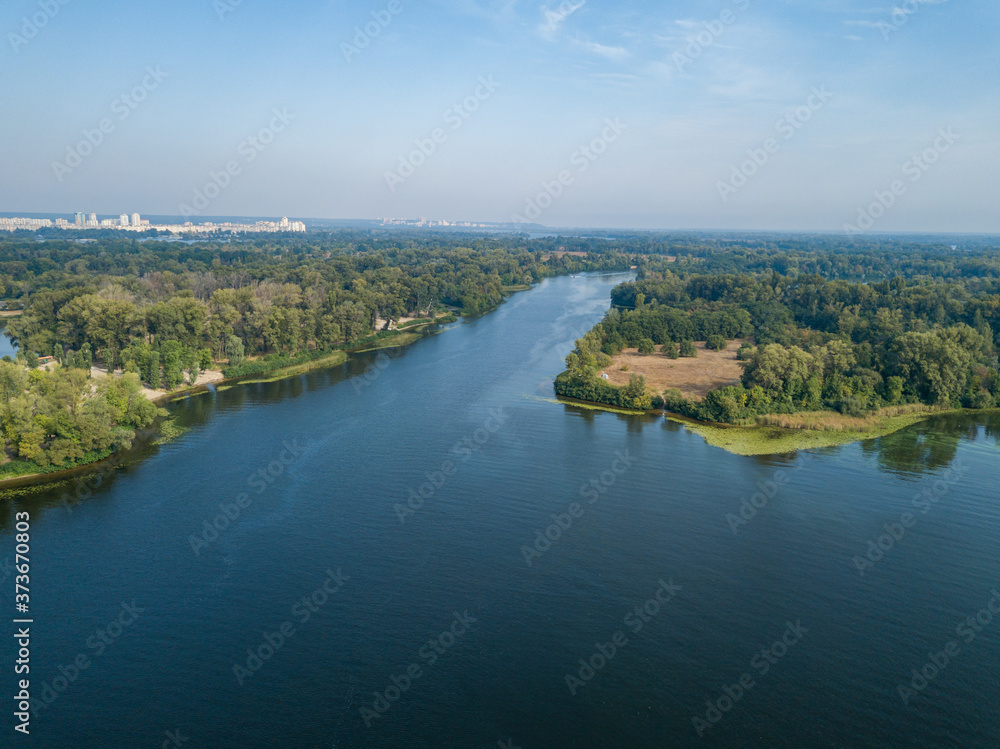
[[0, 275, 1000, 749]]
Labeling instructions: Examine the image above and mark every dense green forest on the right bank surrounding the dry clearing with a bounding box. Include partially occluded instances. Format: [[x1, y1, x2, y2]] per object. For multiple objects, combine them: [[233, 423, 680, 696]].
[[556, 252, 1000, 424]]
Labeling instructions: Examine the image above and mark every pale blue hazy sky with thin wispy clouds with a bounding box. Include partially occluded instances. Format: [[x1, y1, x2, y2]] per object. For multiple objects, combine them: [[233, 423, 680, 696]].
[[0, 0, 1000, 233]]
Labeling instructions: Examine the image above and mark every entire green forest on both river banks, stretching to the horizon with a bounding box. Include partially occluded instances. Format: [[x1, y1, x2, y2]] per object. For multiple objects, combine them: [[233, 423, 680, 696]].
[[0, 229, 1000, 474]]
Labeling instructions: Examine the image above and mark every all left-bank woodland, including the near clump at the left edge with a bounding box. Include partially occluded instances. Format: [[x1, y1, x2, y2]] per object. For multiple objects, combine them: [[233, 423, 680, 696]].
[[0, 232, 630, 474]]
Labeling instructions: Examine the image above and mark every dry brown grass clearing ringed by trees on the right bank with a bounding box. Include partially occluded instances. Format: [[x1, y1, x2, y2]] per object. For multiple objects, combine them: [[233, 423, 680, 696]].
[[602, 339, 743, 400]]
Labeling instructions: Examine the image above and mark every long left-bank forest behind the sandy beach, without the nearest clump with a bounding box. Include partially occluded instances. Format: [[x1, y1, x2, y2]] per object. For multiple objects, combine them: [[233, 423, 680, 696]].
[[0, 238, 628, 388]]
